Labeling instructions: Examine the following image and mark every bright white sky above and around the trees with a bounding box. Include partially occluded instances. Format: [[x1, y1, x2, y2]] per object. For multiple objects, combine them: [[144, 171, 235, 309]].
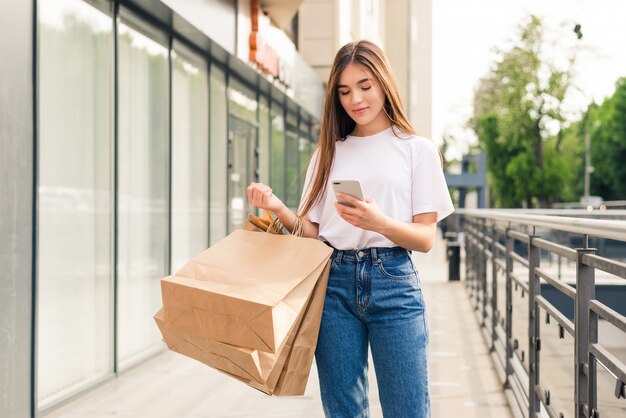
[[432, 0, 626, 158]]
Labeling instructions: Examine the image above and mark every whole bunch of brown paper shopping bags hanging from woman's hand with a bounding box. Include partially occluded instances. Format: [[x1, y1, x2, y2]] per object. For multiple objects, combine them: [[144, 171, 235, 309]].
[[155, 212, 332, 395]]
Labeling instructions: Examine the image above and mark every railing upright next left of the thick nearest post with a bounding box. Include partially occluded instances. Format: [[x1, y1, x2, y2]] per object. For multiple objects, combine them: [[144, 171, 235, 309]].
[[528, 233, 541, 418]]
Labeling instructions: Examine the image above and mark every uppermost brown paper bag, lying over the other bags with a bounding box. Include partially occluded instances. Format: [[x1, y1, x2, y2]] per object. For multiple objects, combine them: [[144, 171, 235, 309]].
[[161, 224, 332, 353]]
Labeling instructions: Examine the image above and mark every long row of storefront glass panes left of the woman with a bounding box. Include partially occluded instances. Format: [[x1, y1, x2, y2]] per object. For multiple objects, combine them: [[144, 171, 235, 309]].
[[35, 0, 311, 411]]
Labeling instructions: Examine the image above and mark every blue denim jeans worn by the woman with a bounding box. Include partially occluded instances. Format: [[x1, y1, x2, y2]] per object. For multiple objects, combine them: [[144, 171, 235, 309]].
[[315, 247, 430, 418]]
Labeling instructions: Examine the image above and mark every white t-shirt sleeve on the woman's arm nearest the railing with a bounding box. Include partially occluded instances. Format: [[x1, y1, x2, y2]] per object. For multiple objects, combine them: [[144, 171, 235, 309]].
[[411, 138, 454, 222]]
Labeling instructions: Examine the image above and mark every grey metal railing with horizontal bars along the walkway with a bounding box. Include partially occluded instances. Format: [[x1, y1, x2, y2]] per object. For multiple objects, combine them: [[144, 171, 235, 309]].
[[459, 210, 626, 418]]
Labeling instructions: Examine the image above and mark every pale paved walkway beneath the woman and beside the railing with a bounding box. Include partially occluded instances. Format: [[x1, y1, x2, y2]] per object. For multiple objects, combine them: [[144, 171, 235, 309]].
[[47, 232, 512, 418]]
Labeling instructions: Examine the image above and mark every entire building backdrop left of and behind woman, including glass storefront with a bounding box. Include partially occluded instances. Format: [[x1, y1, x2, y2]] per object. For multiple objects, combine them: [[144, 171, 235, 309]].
[[0, 0, 432, 417]]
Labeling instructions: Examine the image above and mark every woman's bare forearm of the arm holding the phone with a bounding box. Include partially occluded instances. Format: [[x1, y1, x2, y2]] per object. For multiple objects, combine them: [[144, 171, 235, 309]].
[[378, 219, 437, 253]]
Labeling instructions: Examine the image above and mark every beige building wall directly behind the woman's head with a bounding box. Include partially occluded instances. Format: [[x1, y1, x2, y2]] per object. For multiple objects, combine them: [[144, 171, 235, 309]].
[[299, 0, 432, 137]]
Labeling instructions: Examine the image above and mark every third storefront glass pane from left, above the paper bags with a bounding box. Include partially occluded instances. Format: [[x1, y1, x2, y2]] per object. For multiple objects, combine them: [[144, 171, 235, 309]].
[[171, 45, 209, 272]]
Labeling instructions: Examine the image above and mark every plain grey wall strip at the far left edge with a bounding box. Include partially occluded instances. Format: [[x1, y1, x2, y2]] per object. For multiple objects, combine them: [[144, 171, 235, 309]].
[[0, 1, 35, 417]]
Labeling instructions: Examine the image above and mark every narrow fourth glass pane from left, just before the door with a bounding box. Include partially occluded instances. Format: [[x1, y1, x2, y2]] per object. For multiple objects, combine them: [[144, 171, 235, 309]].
[[210, 65, 228, 244]]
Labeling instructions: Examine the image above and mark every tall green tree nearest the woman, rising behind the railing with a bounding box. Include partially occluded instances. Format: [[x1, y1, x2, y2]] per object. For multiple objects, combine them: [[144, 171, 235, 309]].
[[470, 15, 575, 207]]
